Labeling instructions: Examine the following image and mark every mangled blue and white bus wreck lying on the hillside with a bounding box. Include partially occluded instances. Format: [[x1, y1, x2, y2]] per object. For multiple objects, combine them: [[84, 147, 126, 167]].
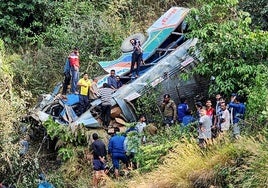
[[29, 7, 207, 128]]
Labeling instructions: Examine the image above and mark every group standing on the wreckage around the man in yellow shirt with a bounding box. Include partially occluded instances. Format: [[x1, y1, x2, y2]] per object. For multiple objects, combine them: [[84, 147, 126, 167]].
[[61, 48, 123, 119]]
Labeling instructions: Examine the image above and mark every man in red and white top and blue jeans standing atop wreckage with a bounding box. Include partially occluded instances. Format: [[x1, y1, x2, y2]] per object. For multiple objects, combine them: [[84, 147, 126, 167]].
[[68, 48, 80, 93]]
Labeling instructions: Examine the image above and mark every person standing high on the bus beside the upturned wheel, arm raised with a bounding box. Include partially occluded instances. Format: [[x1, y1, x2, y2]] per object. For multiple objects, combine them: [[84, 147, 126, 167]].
[[130, 39, 143, 78]]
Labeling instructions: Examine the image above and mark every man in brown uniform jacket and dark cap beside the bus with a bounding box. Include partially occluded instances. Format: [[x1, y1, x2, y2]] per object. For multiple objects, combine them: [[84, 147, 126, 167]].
[[161, 94, 177, 126]]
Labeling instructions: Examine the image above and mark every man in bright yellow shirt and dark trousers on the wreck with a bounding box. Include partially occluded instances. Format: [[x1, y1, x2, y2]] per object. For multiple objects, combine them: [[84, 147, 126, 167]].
[[77, 73, 91, 115]]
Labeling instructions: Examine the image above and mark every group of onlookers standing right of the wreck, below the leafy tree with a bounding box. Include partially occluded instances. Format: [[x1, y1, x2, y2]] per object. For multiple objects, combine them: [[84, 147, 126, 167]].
[[161, 93, 246, 147]]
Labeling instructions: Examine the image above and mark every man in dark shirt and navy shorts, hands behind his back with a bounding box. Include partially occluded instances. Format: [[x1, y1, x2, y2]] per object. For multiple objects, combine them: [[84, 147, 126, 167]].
[[91, 133, 107, 187]]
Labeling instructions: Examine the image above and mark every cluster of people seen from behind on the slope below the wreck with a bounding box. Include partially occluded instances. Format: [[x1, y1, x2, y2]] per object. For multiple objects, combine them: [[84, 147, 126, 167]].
[[91, 115, 147, 187]]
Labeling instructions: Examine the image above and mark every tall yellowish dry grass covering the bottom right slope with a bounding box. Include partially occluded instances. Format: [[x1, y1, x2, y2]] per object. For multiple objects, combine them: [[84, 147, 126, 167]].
[[122, 130, 268, 188]]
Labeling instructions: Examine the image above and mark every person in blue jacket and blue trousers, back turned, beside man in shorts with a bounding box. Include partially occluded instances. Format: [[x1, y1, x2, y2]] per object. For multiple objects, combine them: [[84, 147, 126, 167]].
[[108, 127, 127, 179]]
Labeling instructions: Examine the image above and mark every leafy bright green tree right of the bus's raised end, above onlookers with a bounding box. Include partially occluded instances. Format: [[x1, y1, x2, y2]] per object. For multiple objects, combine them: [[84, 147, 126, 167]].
[[188, 0, 268, 95]]
